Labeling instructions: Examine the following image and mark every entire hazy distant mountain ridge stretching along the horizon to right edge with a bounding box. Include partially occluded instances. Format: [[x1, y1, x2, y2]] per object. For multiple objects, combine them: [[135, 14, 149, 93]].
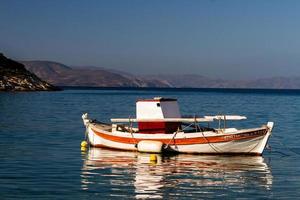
[[22, 61, 300, 89]]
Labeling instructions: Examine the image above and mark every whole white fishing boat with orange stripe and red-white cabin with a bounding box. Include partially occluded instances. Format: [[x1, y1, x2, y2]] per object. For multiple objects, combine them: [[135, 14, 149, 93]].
[[82, 97, 274, 155]]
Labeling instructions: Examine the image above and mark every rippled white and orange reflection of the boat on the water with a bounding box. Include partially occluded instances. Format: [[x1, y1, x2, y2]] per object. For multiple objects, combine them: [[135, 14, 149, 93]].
[[81, 148, 273, 198]]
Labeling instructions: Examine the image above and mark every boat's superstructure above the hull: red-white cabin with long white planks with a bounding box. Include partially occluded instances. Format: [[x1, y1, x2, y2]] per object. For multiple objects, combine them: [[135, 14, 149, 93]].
[[111, 97, 246, 134]]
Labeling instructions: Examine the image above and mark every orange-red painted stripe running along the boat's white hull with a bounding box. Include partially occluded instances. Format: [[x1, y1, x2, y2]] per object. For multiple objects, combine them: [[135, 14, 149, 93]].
[[92, 129, 268, 145]]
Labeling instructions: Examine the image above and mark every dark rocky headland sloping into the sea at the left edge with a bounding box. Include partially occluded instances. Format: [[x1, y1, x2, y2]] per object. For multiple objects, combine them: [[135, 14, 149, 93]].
[[0, 53, 58, 91]]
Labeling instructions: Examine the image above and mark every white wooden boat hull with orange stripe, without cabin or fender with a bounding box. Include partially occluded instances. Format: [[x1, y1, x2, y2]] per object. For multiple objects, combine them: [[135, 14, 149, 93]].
[[87, 122, 273, 155]]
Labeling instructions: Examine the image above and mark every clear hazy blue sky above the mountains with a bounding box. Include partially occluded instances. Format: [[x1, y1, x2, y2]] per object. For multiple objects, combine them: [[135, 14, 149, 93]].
[[0, 0, 300, 78]]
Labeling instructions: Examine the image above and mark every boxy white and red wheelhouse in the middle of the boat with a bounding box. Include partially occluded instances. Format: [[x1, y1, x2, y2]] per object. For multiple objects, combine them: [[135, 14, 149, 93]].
[[136, 97, 181, 133]]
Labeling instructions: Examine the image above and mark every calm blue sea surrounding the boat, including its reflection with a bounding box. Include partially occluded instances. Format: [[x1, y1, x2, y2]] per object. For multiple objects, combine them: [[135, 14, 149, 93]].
[[0, 90, 300, 199]]
